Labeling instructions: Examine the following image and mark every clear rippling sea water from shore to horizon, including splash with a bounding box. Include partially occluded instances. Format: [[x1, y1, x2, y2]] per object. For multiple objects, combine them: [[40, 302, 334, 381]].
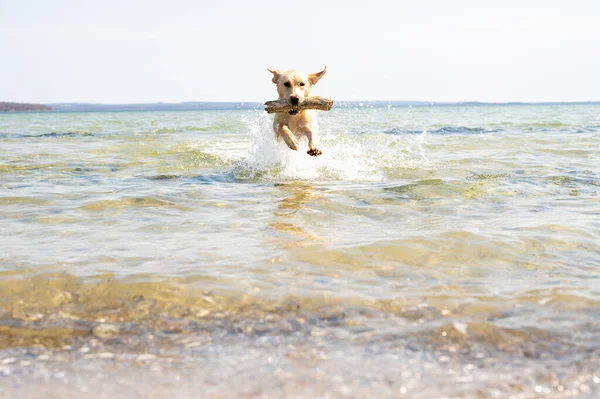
[[0, 104, 600, 398]]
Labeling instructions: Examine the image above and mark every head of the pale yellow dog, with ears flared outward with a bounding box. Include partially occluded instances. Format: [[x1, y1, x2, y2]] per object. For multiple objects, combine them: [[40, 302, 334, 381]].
[[267, 67, 327, 112]]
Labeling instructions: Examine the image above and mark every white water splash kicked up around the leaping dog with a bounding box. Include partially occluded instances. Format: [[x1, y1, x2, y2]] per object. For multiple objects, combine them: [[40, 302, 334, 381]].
[[234, 113, 433, 181]]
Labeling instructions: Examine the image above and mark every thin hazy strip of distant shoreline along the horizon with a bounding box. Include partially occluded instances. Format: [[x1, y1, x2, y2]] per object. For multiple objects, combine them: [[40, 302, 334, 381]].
[[0, 101, 600, 113]]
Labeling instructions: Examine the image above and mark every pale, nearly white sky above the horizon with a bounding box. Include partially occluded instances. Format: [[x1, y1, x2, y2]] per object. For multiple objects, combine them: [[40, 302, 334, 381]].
[[0, 0, 600, 103]]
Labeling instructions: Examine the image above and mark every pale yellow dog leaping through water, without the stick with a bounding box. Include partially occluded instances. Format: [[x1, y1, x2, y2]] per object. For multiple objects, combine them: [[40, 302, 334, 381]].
[[267, 67, 327, 157]]
